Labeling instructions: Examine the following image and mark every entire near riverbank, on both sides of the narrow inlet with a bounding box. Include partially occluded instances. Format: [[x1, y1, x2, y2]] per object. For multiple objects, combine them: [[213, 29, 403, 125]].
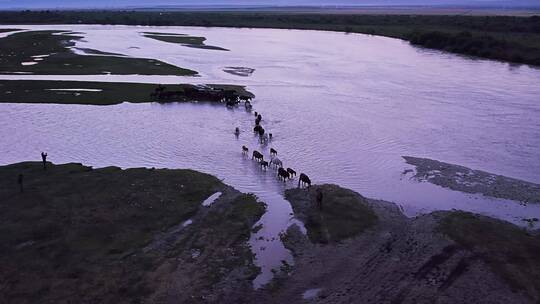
[[0, 162, 540, 303]]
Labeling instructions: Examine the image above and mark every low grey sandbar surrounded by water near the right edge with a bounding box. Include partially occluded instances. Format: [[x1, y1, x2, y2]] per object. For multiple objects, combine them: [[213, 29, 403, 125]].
[[403, 156, 540, 204]]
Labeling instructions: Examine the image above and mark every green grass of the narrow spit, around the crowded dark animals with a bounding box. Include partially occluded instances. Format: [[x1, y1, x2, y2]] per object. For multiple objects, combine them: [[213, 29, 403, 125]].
[[0, 80, 253, 105]]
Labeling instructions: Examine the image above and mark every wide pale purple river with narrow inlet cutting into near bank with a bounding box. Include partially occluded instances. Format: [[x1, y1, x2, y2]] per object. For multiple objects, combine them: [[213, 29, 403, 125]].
[[0, 25, 540, 286]]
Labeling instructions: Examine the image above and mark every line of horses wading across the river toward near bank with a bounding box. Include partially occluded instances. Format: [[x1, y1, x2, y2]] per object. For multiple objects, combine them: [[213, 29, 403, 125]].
[[240, 108, 311, 188]]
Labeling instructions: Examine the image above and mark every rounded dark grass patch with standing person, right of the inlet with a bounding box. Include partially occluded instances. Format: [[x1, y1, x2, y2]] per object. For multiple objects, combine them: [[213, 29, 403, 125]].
[[285, 185, 378, 243]]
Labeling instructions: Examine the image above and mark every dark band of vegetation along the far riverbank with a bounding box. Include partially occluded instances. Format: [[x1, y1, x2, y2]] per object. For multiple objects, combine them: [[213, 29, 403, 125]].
[[0, 11, 540, 66]]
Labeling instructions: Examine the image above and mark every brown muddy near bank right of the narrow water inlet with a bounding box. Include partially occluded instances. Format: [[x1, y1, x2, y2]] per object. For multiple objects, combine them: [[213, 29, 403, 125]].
[[265, 185, 540, 303]]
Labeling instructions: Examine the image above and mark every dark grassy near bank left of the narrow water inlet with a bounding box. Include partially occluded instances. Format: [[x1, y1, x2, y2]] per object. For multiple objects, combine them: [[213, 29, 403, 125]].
[[0, 162, 265, 303]]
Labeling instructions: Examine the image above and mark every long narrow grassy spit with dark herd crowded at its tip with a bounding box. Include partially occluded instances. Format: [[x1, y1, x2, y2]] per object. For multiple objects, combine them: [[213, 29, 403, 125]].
[[0, 80, 254, 105]]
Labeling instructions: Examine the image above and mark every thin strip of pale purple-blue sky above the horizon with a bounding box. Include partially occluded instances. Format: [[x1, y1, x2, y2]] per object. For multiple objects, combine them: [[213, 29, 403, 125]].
[[0, 0, 540, 9]]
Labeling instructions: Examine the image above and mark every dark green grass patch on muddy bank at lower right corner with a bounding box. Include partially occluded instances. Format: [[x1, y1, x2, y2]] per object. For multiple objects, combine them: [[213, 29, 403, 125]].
[[438, 211, 540, 302]]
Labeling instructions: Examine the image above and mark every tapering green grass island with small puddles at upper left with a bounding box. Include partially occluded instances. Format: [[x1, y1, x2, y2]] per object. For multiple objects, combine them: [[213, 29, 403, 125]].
[[0, 31, 197, 76]]
